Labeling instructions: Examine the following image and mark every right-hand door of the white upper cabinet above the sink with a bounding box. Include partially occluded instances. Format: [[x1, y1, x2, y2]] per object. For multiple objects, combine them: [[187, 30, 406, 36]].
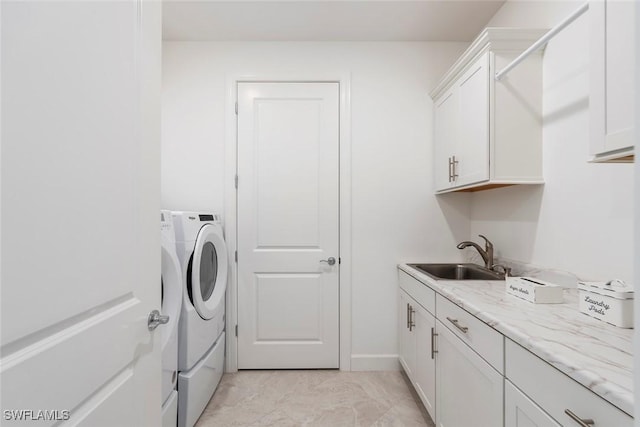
[[453, 52, 489, 186]]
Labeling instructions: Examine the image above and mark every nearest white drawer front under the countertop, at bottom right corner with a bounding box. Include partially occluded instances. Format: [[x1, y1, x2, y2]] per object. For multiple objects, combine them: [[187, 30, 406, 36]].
[[505, 339, 633, 427]]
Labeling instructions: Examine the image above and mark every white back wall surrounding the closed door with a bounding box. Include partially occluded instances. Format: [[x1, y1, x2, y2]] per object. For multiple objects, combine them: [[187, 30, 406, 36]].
[[162, 42, 469, 369]]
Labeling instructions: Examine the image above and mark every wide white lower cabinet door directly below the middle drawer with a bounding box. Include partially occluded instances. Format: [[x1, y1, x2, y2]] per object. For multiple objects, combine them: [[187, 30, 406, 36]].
[[436, 319, 503, 427]]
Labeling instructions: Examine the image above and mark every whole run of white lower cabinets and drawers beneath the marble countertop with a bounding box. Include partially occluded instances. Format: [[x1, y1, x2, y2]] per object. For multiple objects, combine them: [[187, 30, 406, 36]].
[[398, 271, 634, 427]]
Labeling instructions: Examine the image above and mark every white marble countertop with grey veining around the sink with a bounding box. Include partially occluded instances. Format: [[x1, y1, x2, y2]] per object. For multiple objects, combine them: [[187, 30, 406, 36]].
[[399, 264, 634, 415]]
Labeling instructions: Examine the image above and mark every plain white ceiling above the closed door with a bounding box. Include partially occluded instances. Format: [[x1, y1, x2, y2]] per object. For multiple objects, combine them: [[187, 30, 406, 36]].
[[162, 0, 505, 41]]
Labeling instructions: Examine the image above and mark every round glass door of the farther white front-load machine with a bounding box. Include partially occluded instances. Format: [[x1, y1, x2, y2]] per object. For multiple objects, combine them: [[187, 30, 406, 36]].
[[188, 224, 228, 320]]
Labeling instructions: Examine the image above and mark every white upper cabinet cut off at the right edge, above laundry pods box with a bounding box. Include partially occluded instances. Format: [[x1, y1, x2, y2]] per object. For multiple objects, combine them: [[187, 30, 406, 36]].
[[589, 0, 637, 162]]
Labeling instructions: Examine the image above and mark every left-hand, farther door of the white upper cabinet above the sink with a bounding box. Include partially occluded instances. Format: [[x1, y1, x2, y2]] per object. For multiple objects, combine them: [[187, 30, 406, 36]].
[[434, 87, 458, 191]]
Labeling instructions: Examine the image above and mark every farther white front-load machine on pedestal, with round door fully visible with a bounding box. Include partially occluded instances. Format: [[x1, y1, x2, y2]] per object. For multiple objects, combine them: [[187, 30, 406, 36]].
[[172, 212, 229, 427]]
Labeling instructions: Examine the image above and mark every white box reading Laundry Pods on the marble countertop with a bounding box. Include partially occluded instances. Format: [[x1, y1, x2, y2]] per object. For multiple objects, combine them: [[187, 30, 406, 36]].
[[578, 280, 633, 328]]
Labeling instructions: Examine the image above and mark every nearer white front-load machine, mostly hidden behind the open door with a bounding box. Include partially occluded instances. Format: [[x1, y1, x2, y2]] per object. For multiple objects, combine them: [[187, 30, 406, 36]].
[[160, 211, 183, 427]]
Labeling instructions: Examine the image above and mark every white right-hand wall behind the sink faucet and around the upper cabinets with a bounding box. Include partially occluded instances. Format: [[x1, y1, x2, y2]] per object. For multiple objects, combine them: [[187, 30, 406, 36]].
[[471, 1, 633, 280]]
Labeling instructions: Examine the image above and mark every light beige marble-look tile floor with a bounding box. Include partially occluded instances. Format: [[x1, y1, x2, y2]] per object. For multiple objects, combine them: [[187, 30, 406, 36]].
[[196, 370, 434, 427]]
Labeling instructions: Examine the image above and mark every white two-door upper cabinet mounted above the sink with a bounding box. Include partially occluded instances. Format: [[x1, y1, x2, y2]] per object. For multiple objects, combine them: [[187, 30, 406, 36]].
[[431, 28, 545, 193]]
